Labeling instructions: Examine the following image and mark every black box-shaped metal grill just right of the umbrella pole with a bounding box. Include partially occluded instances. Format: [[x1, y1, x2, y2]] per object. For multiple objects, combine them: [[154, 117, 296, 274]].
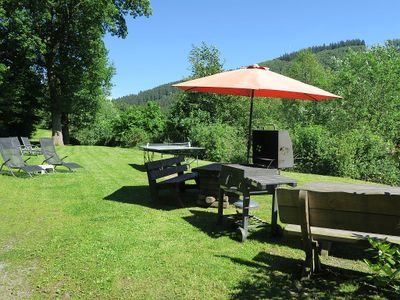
[[252, 130, 294, 169]]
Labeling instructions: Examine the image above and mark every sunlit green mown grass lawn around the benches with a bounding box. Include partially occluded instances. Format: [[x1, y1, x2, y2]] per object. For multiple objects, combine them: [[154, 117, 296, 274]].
[[0, 146, 396, 299]]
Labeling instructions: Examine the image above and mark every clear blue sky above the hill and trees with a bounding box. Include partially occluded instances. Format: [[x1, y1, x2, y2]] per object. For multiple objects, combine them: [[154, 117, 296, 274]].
[[104, 0, 400, 98]]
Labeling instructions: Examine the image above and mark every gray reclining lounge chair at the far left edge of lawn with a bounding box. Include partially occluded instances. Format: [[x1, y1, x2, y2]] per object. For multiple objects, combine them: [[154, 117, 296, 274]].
[[0, 138, 43, 177]]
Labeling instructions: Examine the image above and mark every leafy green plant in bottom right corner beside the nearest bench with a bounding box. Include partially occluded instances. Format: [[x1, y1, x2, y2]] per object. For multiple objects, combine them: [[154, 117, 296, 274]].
[[364, 238, 400, 292]]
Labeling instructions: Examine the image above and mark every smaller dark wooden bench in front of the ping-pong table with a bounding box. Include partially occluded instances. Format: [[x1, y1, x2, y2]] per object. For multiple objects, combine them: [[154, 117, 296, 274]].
[[145, 156, 197, 207]]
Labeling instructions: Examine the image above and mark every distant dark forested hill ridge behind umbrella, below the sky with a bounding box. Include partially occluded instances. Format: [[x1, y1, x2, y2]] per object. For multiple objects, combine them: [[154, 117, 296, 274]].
[[115, 39, 366, 110]]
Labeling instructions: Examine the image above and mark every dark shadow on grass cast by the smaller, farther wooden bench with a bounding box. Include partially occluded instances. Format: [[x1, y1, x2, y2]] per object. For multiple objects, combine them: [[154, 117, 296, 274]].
[[104, 185, 197, 210]]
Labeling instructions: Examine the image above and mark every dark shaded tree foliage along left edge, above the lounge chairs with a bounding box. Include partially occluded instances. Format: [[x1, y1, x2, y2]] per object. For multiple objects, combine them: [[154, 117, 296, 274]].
[[0, 2, 44, 136]]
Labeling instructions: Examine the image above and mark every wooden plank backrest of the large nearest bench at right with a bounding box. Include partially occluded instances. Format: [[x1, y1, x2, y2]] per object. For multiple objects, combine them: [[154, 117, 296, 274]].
[[277, 188, 400, 236]]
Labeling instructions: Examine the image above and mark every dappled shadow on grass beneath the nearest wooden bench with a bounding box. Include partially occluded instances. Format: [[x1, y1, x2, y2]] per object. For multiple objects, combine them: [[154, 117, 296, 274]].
[[220, 252, 396, 299]]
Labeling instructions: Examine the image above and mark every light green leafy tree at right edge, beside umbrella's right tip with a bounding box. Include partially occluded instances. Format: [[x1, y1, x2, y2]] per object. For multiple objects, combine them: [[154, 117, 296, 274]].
[[330, 43, 400, 143]]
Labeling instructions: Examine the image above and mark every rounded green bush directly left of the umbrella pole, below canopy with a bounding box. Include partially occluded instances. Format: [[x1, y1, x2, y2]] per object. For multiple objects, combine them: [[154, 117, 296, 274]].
[[189, 123, 246, 162]]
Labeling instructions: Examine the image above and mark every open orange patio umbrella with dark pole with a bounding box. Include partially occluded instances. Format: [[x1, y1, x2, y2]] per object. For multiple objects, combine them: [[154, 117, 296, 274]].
[[173, 64, 342, 160]]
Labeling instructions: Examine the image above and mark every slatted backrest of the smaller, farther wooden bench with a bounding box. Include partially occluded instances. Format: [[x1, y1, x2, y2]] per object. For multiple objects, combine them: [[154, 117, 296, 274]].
[[145, 156, 187, 182]]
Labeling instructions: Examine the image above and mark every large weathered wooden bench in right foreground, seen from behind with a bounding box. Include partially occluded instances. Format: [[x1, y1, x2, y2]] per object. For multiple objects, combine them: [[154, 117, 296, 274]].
[[277, 183, 400, 277]]
